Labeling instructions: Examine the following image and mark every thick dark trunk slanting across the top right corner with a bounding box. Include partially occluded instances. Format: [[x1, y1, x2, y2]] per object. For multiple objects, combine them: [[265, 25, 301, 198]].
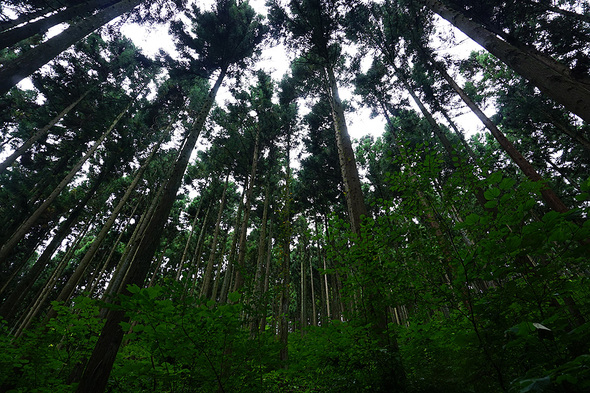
[[423, 0, 590, 122]]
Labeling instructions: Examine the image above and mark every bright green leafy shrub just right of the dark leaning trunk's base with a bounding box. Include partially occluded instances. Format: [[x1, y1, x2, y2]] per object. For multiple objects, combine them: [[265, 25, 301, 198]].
[[111, 286, 278, 392]]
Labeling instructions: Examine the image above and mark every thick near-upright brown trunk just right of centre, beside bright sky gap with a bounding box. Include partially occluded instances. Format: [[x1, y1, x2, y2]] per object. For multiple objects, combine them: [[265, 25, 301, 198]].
[[325, 67, 367, 235]]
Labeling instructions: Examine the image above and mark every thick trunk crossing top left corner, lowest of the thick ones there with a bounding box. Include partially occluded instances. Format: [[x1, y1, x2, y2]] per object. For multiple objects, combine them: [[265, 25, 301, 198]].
[[0, 0, 142, 95]]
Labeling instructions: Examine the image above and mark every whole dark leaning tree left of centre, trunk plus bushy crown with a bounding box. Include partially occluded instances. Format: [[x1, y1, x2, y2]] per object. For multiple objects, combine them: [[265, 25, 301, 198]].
[[77, 0, 265, 392]]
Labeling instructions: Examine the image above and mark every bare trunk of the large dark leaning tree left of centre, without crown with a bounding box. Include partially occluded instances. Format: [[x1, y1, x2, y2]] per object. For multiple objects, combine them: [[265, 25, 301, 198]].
[[76, 67, 227, 393]]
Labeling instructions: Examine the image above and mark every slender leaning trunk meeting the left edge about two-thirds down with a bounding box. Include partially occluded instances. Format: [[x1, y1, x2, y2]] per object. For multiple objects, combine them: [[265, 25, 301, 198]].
[[0, 99, 131, 265]]
